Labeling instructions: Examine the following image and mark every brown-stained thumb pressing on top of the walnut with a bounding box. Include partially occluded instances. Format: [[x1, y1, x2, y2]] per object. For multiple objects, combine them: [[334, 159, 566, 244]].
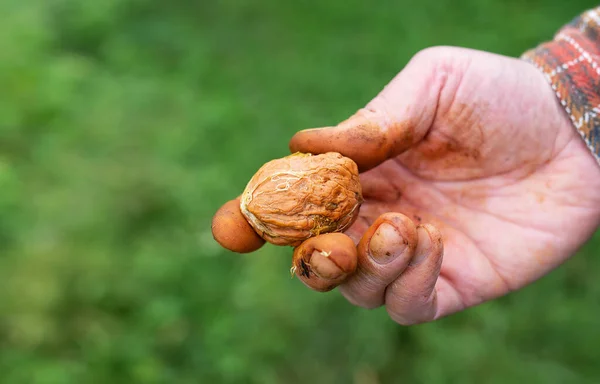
[[289, 49, 446, 172]]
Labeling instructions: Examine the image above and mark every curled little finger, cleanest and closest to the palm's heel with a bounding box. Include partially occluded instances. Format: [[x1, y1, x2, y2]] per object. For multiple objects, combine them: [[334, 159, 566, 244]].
[[385, 224, 444, 325]]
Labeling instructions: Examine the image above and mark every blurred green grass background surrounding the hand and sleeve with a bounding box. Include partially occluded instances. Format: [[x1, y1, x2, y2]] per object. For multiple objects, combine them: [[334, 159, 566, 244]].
[[0, 0, 600, 384]]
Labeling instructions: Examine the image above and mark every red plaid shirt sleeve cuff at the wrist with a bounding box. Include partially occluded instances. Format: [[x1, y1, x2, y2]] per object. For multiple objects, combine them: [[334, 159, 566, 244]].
[[522, 7, 600, 164]]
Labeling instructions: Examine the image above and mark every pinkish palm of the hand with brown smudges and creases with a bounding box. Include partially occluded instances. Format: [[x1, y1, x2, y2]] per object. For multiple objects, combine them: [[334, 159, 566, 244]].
[[340, 51, 600, 316]]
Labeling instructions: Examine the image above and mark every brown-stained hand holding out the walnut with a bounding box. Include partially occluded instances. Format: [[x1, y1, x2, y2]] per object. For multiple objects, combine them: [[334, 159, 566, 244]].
[[213, 47, 600, 325]]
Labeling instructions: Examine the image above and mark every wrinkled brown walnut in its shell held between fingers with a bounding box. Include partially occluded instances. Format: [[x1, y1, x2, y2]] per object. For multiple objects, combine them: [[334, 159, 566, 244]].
[[240, 152, 363, 246]]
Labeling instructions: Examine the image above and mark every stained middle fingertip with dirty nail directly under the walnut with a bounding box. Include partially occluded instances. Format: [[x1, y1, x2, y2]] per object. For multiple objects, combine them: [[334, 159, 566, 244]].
[[292, 233, 357, 292]]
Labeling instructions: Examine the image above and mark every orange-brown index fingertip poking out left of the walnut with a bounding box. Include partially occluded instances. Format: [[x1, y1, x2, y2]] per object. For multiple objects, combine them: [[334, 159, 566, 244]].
[[212, 197, 265, 253]]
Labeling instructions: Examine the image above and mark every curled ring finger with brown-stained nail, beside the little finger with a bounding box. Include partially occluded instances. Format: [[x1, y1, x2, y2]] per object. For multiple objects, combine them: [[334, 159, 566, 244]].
[[340, 213, 417, 308]]
